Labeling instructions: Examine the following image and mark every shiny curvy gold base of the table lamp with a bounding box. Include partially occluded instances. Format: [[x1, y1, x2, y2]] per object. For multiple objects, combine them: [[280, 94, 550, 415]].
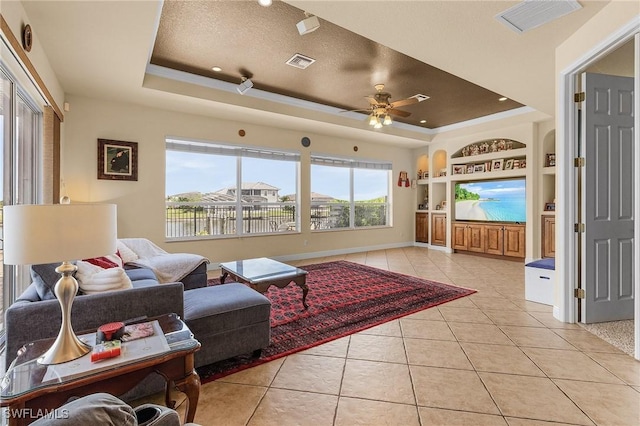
[[38, 262, 91, 365]]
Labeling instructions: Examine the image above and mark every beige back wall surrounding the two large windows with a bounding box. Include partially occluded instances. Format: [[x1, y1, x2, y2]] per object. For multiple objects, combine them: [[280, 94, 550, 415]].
[[61, 95, 415, 262]]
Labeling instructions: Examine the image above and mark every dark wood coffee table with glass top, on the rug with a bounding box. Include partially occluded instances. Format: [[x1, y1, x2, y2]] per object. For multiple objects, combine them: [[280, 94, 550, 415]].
[[220, 257, 309, 309]]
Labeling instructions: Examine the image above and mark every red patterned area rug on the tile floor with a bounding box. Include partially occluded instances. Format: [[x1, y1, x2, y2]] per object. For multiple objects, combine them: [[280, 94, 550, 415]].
[[198, 261, 475, 383]]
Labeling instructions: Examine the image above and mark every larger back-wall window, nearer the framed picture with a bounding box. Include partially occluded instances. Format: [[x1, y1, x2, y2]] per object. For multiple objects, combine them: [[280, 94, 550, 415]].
[[165, 139, 300, 239]]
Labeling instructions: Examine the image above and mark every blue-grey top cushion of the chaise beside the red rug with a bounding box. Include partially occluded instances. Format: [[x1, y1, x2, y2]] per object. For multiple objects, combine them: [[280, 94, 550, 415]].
[[184, 283, 271, 336]]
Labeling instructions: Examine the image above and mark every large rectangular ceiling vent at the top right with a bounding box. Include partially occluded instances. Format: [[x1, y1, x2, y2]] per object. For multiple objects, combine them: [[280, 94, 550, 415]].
[[496, 0, 582, 33]]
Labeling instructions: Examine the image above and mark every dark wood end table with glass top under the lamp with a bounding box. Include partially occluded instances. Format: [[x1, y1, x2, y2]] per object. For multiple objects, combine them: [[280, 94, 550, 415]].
[[0, 314, 200, 426]]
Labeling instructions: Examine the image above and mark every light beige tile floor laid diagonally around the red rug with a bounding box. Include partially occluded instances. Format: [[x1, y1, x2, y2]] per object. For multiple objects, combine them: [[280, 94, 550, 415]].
[[138, 247, 640, 426]]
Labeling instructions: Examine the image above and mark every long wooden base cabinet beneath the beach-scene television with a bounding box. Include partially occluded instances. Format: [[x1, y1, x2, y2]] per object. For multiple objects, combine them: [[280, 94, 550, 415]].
[[451, 222, 525, 258]]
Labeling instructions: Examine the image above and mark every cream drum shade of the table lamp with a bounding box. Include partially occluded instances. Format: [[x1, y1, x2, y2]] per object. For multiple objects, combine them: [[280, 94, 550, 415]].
[[3, 204, 118, 265]]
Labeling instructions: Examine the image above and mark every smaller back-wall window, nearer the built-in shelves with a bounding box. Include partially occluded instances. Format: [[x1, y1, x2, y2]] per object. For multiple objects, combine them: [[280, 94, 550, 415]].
[[311, 155, 392, 230]]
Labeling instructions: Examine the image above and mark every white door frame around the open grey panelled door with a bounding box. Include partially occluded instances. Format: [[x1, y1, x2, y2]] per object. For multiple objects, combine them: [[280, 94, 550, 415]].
[[553, 17, 640, 360]]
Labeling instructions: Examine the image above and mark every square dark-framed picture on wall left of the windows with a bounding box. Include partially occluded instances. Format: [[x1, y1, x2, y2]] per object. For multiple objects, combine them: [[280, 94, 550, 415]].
[[98, 139, 138, 181]]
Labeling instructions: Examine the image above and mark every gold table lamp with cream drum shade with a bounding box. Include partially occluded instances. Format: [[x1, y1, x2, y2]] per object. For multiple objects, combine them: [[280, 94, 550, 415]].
[[3, 204, 117, 365]]
